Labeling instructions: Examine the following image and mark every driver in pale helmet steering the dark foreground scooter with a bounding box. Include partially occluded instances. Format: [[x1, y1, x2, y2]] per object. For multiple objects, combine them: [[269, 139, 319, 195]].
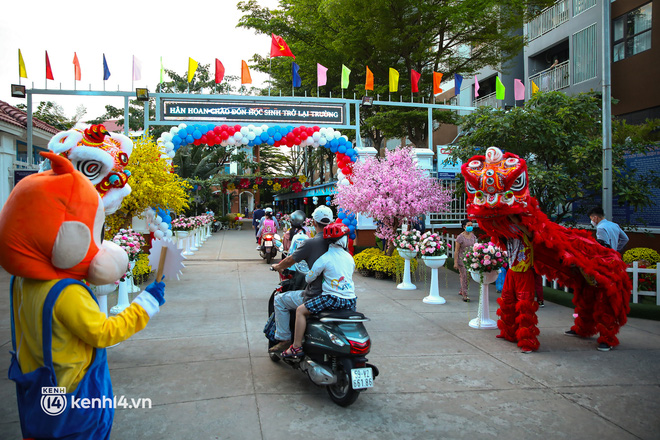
[[269, 206, 334, 352]]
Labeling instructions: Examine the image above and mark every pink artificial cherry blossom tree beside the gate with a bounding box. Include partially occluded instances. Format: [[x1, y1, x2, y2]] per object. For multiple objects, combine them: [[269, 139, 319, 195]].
[[333, 148, 452, 255]]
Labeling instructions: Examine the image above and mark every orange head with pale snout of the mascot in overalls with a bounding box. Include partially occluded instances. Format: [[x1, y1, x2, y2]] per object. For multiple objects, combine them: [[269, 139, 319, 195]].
[[0, 153, 128, 285]]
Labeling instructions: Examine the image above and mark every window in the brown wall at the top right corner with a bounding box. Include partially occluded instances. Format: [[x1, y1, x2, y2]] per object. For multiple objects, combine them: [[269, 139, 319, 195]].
[[612, 3, 652, 62]]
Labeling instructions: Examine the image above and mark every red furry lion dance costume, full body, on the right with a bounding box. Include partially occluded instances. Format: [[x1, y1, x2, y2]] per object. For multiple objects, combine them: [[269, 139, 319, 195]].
[[461, 147, 631, 351]]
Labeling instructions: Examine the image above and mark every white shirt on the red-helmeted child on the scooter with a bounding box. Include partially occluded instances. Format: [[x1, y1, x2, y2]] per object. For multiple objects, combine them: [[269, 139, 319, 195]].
[[305, 245, 355, 299]]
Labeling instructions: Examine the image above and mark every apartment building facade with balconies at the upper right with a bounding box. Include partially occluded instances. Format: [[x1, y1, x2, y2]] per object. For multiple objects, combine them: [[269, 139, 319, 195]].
[[459, 0, 660, 123]]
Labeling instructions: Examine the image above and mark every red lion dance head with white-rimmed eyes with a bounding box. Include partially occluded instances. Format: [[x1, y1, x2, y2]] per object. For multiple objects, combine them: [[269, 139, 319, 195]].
[[461, 147, 530, 219]]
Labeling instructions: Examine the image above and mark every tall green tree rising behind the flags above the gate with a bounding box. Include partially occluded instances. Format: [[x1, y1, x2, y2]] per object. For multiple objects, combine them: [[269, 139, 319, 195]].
[[238, 0, 554, 148]]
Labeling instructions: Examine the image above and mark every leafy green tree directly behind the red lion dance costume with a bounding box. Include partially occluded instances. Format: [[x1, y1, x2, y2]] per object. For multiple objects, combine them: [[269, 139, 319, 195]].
[[453, 92, 660, 221]]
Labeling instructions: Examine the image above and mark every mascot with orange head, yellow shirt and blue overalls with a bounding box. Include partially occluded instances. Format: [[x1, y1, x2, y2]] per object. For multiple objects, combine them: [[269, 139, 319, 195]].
[[0, 153, 165, 440]]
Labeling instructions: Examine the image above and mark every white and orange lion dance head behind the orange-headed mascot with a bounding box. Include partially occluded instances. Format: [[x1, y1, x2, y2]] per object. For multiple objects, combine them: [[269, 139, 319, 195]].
[[48, 125, 133, 215]]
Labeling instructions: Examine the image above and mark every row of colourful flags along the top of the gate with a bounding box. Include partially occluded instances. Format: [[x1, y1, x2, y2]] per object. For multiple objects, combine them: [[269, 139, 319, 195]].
[[18, 34, 539, 101]]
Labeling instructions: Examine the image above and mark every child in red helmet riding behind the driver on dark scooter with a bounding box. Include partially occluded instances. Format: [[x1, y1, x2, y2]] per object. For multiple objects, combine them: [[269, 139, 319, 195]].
[[282, 223, 356, 357]]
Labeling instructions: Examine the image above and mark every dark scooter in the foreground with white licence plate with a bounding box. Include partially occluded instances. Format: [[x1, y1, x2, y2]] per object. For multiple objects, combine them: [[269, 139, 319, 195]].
[[264, 269, 379, 407]]
